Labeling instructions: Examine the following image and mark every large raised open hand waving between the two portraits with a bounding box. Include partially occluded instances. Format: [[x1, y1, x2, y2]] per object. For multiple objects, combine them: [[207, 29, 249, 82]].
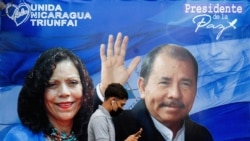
[[97, 32, 140, 95]]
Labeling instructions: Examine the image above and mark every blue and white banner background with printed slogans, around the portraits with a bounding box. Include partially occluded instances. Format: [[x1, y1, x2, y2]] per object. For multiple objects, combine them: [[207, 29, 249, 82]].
[[0, 0, 250, 141]]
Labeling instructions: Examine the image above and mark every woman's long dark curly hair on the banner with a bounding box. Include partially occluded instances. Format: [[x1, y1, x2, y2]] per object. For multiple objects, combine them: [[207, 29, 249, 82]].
[[18, 47, 94, 141]]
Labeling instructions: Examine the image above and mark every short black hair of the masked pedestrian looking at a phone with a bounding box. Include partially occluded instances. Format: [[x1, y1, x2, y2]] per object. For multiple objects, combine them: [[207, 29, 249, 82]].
[[104, 83, 128, 100]]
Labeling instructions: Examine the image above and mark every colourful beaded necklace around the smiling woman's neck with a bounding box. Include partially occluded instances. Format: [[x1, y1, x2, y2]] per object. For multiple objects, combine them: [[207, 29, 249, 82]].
[[48, 127, 77, 141]]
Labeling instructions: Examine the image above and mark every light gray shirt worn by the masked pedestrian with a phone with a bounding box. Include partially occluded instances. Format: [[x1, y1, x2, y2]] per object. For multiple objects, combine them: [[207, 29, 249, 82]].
[[88, 105, 115, 141]]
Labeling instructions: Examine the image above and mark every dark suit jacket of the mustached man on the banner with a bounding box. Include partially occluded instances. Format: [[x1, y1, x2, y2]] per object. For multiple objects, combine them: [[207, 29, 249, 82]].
[[94, 93, 213, 141]]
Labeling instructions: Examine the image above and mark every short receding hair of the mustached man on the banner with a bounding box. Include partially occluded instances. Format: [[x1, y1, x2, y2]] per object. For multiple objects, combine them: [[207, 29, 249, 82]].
[[140, 44, 198, 84]]
